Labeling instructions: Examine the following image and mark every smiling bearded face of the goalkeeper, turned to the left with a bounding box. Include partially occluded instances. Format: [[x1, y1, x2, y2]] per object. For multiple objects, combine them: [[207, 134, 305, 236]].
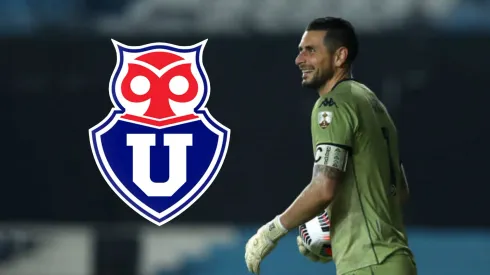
[[295, 31, 334, 90]]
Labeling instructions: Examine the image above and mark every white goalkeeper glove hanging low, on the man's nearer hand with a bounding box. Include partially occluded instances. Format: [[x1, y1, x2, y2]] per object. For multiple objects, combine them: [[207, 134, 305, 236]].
[[245, 216, 288, 274]]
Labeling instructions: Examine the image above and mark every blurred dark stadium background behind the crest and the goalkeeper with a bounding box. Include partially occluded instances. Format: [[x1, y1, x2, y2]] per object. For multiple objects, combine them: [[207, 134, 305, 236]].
[[0, 0, 490, 275]]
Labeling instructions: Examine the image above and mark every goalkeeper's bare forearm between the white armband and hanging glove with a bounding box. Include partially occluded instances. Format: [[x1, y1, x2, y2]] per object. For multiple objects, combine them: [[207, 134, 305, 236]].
[[280, 164, 343, 230]]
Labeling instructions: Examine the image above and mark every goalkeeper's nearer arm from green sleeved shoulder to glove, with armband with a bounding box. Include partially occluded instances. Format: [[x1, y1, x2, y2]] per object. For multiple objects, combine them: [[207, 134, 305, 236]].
[[280, 93, 358, 230]]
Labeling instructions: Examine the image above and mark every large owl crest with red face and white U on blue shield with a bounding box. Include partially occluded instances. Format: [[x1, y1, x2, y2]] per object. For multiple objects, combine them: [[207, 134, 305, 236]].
[[89, 40, 230, 225]]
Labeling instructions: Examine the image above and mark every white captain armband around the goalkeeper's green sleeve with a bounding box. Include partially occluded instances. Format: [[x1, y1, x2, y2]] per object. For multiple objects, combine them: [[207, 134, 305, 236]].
[[315, 143, 349, 172]]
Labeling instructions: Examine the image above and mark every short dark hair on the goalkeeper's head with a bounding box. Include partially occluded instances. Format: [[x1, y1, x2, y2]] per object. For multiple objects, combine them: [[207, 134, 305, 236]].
[[306, 17, 359, 65]]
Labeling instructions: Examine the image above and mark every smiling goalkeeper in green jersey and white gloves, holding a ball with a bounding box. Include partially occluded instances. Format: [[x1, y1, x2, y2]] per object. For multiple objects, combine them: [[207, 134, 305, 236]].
[[245, 17, 417, 275]]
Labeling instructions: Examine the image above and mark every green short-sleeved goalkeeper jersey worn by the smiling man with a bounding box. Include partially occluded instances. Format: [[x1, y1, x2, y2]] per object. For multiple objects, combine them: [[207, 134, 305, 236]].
[[311, 79, 412, 274]]
